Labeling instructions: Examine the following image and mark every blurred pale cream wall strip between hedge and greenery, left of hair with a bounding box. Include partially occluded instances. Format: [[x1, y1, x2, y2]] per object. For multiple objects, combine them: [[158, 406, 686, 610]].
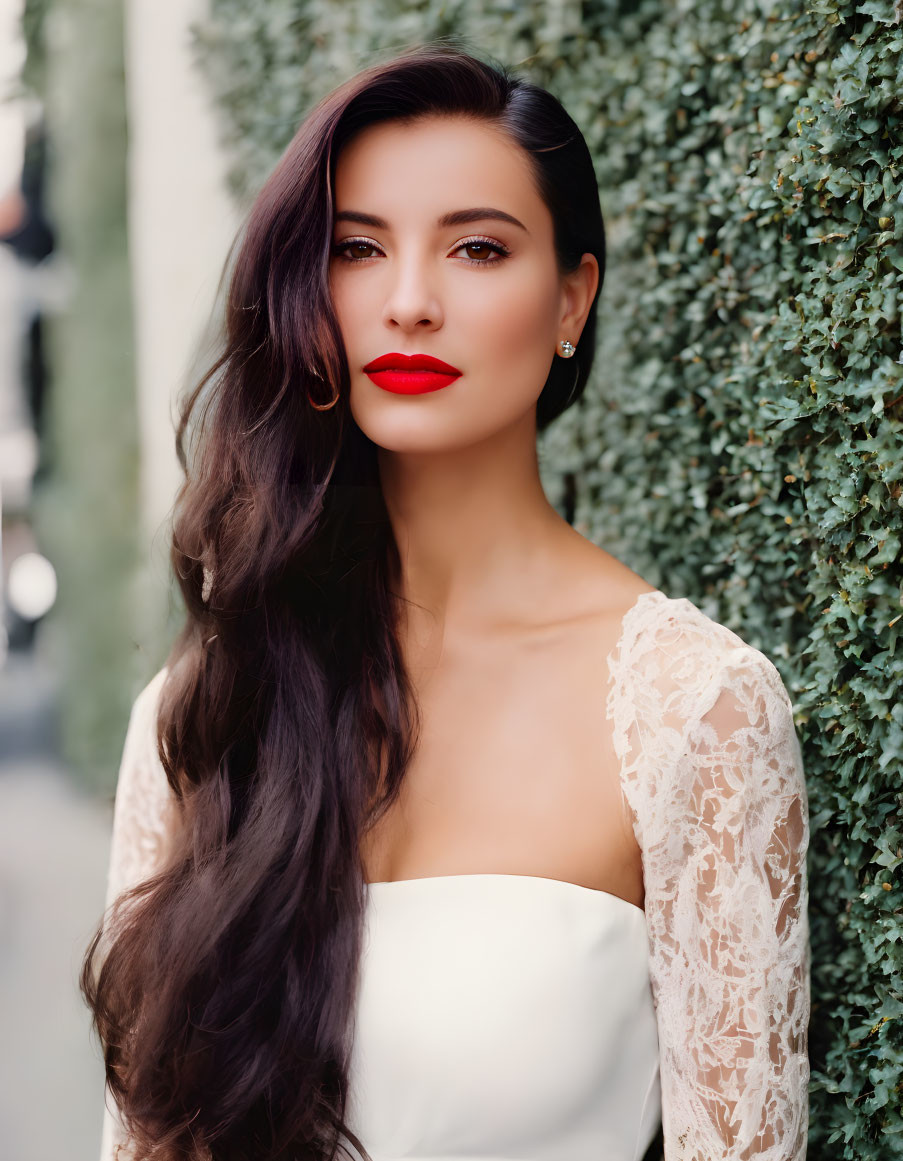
[[125, 0, 239, 616]]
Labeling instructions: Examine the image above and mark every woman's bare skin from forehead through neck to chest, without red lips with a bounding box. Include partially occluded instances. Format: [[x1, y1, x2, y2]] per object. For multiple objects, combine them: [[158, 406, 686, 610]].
[[330, 116, 652, 906]]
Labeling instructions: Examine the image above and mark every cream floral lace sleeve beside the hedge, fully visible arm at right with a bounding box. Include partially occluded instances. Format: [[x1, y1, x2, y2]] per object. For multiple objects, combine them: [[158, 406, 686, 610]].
[[611, 598, 810, 1161]]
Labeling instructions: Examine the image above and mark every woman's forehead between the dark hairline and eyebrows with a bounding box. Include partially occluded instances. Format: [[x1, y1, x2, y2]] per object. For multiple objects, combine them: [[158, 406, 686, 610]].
[[335, 116, 540, 229]]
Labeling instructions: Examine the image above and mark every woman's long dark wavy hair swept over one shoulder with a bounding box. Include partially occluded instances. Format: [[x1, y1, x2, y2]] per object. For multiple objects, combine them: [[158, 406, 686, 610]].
[[80, 42, 605, 1161]]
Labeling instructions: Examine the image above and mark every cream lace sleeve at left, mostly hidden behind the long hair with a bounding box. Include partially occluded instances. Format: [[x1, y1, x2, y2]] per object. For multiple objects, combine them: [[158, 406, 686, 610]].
[[100, 669, 174, 1161]]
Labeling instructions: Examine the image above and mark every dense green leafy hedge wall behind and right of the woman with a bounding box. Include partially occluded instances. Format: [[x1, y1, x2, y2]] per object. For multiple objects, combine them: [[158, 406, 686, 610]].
[[191, 0, 903, 1161]]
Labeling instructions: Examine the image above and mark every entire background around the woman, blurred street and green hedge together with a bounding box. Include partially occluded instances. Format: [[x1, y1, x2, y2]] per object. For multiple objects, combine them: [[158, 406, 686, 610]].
[[0, 0, 903, 1161]]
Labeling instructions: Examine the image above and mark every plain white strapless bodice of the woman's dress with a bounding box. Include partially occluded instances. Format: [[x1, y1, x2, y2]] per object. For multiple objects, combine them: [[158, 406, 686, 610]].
[[346, 874, 662, 1161]]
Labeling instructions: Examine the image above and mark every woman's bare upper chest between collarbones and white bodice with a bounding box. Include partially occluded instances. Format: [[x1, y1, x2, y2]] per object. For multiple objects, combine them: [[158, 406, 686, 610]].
[[362, 618, 642, 906]]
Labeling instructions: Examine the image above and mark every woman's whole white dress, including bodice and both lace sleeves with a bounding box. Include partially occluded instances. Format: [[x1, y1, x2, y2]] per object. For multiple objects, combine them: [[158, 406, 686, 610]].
[[101, 591, 810, 1161]]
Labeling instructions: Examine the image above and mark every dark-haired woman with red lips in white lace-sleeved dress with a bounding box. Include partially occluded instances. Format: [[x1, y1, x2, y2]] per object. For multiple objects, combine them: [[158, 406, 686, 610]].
[[81, 43, 809, 1161]]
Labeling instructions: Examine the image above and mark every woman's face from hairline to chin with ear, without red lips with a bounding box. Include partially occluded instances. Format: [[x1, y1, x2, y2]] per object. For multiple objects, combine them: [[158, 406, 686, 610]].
[[330, 116, 599, 452]]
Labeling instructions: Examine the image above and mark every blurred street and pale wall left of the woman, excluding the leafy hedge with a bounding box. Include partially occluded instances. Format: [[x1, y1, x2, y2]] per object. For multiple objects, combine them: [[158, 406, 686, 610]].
[[0, 0, 238, 1161]]
